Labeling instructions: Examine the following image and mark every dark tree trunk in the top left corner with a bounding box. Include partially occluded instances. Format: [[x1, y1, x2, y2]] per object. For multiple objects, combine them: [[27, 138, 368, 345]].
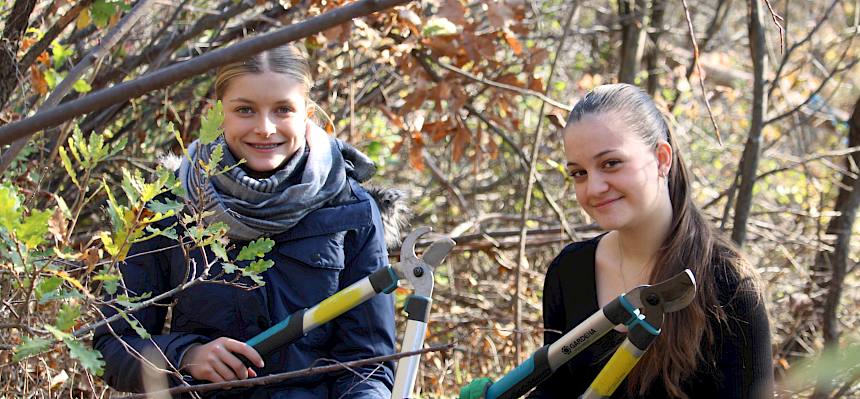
[[0, 0, 36, 109]]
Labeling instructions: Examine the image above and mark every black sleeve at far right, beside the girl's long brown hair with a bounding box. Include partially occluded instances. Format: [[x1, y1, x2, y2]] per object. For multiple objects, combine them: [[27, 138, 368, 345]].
[[716, 281, 774, 399]]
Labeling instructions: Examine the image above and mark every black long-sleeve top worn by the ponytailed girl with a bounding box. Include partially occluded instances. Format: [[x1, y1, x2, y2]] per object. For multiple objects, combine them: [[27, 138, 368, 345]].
[[529, 237, 773, 399]]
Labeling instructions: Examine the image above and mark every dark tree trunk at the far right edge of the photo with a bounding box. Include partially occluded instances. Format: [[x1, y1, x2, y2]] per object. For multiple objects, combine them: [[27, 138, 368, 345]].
[[812, 93, 860, 399]]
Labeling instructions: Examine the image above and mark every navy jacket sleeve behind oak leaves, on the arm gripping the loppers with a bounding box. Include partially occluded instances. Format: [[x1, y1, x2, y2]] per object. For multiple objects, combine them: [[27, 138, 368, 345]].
[[93, 237, 208, 392]]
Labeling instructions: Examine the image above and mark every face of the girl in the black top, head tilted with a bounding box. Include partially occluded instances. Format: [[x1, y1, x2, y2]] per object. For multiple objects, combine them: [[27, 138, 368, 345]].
[[563, 112, 672, 230]]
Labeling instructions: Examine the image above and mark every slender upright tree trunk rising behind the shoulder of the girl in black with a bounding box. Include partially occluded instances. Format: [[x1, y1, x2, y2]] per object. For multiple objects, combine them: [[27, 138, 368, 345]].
[[732, 0, 767, 246]]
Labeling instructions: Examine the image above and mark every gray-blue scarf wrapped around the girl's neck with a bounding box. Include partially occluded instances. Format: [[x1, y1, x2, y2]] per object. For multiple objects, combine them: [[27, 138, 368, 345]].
[[179, 126, 376, 240]]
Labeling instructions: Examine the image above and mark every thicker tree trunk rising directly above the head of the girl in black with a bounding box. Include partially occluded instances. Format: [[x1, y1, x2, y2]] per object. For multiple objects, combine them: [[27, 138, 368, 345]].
[[618, 0, 647, 84]]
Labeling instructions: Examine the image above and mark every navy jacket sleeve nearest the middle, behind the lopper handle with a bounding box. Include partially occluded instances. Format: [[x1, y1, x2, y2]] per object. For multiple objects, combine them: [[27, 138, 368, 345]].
[[331, 201, 395, 399]]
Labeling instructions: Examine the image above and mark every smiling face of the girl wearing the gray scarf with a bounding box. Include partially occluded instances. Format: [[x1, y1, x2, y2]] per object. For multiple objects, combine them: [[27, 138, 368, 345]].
[[221, 71, 308, 172]]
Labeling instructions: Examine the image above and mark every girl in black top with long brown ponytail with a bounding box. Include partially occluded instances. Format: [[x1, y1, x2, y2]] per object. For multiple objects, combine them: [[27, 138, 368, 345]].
[[530, 84, 773, 399]]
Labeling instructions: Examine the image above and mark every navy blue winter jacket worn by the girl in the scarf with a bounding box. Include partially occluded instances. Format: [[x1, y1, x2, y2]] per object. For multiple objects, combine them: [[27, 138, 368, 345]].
[[93, 180, 395, 399]]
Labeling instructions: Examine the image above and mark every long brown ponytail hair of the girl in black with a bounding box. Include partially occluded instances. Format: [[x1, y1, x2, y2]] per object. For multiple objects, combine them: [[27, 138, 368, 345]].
[[567, 84, 760, 399]]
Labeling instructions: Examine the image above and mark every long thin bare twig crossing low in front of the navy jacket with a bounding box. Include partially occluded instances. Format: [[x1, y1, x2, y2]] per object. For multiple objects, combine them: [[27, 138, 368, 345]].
[[122, 343, 454, 399]]
